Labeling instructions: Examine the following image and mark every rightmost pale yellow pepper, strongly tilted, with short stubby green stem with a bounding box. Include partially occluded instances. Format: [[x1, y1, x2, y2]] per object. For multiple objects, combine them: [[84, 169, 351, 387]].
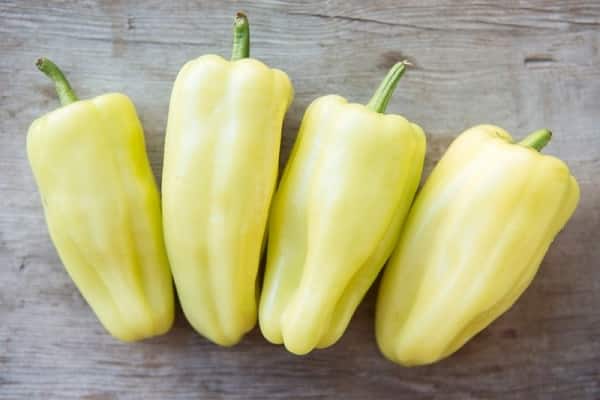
[[376, 125, 579, 366]]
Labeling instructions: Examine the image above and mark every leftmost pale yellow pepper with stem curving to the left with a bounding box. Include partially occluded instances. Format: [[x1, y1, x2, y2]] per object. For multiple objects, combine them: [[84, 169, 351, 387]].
[[27, 59, 173, 341]]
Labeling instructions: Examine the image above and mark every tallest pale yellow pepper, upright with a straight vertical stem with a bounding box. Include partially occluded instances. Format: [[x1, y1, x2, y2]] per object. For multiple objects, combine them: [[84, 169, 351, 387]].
[[162, 14, 293, 346]]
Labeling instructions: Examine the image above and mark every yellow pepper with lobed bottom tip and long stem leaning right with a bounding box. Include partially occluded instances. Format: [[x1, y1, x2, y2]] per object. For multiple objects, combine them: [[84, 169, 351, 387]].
[[259, 63, 425, 354]]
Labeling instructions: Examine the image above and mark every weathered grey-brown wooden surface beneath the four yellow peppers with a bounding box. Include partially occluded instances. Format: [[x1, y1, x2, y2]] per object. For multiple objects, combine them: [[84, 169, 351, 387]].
[[0, 0, 600, 400]]
